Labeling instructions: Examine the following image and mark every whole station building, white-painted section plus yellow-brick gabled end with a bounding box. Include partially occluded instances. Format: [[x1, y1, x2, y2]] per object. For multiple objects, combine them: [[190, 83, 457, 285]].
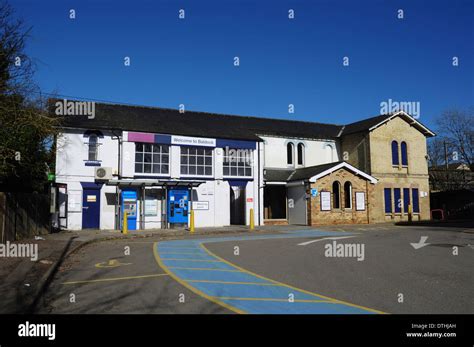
[[50, 100, 434, 230]]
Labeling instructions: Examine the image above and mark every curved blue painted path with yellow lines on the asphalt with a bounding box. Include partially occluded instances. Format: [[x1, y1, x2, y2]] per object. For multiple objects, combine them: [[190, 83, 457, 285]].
[[154, 230, 384, 314]]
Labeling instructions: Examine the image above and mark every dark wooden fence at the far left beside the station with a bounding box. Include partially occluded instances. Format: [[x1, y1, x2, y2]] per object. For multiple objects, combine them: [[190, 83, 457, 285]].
[[0, 192, 51, 243]]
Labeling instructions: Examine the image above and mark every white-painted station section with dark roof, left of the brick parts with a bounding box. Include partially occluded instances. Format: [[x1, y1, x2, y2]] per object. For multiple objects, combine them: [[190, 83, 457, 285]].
[[52, 100, 434, 230]]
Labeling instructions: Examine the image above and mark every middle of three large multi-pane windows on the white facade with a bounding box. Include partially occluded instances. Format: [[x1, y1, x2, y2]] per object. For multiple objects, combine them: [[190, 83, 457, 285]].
[[181, 147, 212, 176]]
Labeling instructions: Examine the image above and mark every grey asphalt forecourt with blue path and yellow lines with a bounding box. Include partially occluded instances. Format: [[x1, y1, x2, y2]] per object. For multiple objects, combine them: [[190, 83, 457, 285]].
[[40, 227, 474, 313]]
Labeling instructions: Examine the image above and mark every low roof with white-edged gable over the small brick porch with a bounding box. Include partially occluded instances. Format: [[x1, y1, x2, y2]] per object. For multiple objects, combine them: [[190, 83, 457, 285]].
[[264, 161, 377, 183]]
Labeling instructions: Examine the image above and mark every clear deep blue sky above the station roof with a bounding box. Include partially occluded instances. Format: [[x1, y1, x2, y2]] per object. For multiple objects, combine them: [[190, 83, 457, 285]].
[[10, 0, 474, 127]]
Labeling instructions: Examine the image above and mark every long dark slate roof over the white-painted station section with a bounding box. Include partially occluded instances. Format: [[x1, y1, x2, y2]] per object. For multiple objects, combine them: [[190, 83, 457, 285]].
[[50, 99, 342, 141]]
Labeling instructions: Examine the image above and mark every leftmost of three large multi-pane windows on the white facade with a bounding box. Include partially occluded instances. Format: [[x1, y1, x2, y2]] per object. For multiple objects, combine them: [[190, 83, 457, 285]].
[[135, 143, 170, 175]]
